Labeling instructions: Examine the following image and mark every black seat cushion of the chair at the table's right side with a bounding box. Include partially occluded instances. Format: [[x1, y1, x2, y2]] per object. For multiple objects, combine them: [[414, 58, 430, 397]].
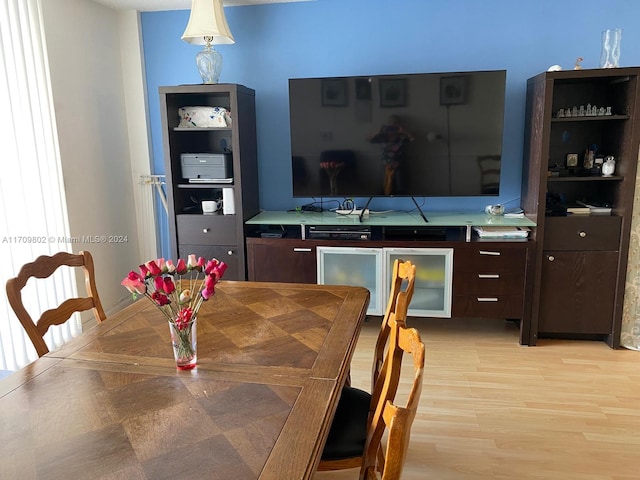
[[322, 387, 371, 460]]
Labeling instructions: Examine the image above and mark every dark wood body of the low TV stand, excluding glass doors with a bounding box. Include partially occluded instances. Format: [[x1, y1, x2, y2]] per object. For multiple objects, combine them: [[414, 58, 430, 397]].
[[247, 234, 533, 344]]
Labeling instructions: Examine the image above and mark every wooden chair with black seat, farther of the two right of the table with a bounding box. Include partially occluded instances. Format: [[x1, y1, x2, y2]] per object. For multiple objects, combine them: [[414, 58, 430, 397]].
[[318, 291, 409, 471]]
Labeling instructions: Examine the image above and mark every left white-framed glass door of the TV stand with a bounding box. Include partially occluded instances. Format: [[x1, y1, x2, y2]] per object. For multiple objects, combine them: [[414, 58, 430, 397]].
[[316, 247, 384, 315]]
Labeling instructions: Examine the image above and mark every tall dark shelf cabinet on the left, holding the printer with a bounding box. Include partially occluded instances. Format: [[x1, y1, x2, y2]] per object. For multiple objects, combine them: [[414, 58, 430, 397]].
[[160, 84, 259, 280]]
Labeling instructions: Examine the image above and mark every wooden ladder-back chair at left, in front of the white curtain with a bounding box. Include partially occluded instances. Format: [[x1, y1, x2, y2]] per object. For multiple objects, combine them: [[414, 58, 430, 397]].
[[6, 251, 107, 357]]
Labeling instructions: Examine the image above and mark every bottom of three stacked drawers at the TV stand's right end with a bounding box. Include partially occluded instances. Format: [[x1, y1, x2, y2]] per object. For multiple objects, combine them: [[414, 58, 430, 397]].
[[452, 294, 523, 318]]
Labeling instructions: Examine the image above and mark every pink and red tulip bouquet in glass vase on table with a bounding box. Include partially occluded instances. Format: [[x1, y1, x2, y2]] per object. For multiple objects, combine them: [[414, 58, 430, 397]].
[[122, 254, 227, 368]]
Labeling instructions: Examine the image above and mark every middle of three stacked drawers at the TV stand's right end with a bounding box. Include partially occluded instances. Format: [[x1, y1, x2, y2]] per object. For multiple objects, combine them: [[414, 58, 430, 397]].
[[453, 271, 524, 296]]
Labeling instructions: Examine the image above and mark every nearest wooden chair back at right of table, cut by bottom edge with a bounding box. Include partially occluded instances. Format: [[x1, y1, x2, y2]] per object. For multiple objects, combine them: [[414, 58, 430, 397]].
[[360, 310, 425, 480]]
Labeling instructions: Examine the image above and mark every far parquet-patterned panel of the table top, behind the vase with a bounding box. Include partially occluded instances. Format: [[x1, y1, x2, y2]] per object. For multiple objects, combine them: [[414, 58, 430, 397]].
[[50, 282, 358, 378]]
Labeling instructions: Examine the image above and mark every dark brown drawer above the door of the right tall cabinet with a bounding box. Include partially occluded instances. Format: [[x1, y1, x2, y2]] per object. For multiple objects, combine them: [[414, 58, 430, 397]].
[[544, 215, 622, 251]]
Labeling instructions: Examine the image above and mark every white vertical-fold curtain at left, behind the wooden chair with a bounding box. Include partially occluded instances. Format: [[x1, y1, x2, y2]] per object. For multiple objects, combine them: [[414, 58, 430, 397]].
[[0, 0, 81, 370]]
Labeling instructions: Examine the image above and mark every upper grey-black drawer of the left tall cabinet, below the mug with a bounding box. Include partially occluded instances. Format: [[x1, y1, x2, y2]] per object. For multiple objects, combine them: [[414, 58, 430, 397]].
[[177, 215, 237, 245]]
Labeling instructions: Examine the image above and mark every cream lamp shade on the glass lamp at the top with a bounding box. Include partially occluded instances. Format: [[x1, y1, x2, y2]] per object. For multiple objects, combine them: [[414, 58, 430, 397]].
[[182, 0, 235, 45]]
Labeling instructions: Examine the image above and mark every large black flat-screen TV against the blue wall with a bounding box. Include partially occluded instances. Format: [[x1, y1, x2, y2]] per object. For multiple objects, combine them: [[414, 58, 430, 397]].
[[289, 70, 506, 197]]
